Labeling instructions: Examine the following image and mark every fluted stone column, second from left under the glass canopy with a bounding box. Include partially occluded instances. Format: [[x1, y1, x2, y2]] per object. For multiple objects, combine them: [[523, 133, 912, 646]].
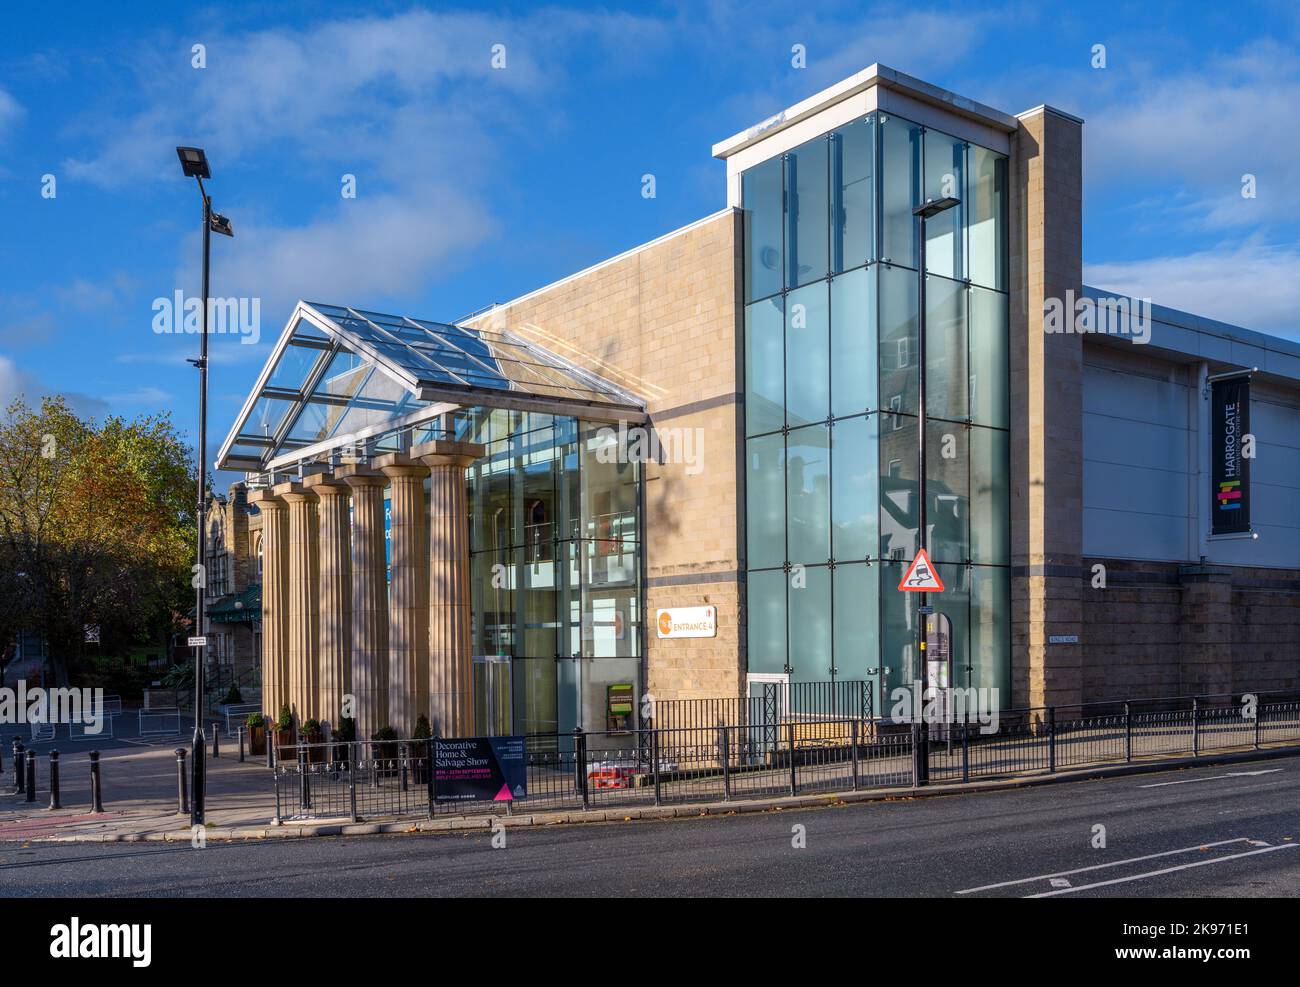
[[273, 482, 320, 723]]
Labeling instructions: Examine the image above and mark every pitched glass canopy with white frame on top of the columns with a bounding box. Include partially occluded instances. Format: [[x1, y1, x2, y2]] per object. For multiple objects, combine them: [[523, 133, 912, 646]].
[[217, 302, 645, 472]]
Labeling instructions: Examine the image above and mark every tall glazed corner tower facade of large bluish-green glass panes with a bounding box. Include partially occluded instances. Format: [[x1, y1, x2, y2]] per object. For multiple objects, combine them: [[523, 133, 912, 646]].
[[742, 113, 1010, 715]]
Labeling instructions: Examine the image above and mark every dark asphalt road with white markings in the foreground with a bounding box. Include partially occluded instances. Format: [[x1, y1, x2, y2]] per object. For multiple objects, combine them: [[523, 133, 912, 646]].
[[0, 758, 1300, 899]]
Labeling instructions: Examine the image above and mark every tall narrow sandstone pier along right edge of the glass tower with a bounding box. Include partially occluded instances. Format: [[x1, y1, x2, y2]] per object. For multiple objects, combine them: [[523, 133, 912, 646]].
[[1009, 107, 1081, 706]]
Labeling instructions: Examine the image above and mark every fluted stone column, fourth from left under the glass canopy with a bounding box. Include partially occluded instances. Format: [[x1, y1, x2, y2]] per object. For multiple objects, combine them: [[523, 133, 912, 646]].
[[337, 466, 389, 740]]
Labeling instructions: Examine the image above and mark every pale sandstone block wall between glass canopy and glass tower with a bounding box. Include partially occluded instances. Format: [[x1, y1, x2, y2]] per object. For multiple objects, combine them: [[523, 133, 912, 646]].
[[475, 209, 745, 698]]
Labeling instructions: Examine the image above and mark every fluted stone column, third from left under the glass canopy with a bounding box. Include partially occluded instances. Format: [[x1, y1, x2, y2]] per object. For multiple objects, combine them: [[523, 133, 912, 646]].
[[303, 473, 352, 728]]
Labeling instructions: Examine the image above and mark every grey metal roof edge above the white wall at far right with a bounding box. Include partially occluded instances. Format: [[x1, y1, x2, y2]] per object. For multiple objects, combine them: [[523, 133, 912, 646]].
[[1083, 285, 1300, 382]]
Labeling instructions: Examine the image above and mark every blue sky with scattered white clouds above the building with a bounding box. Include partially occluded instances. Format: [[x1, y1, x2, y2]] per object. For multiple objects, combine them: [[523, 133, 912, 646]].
[[0, 0, 1300, 455]]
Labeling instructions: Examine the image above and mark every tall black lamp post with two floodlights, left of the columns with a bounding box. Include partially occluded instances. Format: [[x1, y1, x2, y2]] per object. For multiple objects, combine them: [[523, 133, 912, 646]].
[[176, 147, 234, 826]]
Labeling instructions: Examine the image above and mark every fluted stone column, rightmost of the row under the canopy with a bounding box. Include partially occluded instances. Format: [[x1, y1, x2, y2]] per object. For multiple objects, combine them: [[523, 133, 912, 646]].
[[411, 440, 485, 737]]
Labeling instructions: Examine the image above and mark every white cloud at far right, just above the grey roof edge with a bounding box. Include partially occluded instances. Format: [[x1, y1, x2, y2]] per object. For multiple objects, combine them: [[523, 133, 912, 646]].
[[1084, 241, 1300, 342]]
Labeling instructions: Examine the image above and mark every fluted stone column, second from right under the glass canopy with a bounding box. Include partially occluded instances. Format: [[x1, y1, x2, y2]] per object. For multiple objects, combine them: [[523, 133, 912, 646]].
[[374, 453, 429, 737]]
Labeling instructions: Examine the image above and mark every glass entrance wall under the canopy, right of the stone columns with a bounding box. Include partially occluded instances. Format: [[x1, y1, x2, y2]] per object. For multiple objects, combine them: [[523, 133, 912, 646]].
[[458, 408, 641, 733]]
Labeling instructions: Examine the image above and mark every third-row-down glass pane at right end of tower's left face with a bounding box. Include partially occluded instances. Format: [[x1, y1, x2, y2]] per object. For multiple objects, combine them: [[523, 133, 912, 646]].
[[831, 415, 880, 562]]
